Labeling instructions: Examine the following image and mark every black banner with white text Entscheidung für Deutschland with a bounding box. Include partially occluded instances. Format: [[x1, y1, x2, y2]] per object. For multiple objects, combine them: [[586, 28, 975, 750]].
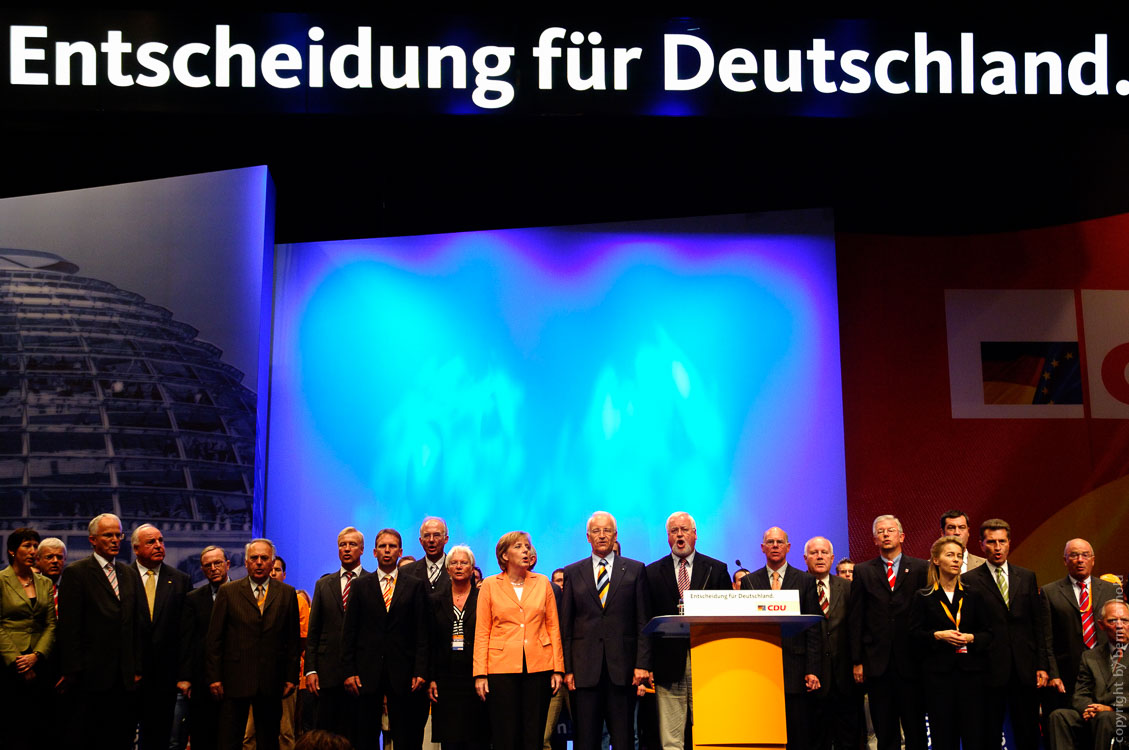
[[0, 11, 1129, 120]]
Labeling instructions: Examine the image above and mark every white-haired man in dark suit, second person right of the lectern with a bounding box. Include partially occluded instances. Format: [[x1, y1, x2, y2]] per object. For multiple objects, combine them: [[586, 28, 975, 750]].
[[804, 537, 865, 750]]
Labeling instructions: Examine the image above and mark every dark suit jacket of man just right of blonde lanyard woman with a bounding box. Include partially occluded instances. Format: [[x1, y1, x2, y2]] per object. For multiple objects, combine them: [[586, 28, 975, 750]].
[[961, 563, 1047, 689]]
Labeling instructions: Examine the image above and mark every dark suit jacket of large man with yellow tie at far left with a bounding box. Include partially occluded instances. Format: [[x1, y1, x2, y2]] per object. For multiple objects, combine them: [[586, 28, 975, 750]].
[[139, 563, 192, 689]]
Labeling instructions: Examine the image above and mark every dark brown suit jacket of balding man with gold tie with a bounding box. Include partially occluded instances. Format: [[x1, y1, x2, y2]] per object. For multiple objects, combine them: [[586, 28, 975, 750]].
[[204, 576, 300, 698]]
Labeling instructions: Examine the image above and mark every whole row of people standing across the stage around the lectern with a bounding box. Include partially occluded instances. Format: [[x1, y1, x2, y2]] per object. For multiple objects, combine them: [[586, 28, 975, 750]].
[[0, 511, 1129, 750]]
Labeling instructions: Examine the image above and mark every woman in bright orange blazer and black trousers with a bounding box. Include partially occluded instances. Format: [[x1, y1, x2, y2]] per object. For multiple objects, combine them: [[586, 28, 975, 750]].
[[474, 531, 565, 750]]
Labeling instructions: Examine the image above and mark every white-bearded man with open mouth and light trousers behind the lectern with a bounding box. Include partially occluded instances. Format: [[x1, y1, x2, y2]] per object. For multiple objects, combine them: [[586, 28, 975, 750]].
[[645, 511, 733, 750]]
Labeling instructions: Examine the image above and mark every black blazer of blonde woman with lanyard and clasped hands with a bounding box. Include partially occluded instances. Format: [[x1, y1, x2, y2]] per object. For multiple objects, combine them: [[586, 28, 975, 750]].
[[912, 582, 992, 674]]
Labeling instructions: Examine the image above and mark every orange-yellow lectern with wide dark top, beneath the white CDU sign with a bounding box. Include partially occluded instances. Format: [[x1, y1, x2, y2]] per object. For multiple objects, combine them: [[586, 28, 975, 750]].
[[644, 614, 823, 750]]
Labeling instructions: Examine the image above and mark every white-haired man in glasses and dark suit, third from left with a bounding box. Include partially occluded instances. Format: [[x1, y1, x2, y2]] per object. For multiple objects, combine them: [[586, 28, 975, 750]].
[[58, 513, 145, 748]]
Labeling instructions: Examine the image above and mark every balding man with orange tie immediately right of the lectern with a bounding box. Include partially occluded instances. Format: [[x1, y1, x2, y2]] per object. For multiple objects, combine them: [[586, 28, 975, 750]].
[[741, 526, 823, 750]]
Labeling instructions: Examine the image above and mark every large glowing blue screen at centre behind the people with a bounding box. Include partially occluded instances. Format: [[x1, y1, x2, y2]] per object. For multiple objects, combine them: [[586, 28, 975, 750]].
[[265, 211, 847, 588]]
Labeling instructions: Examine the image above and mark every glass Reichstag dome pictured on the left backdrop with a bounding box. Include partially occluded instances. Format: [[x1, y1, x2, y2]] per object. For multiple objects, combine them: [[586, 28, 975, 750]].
[[0, 248, 255, 578]]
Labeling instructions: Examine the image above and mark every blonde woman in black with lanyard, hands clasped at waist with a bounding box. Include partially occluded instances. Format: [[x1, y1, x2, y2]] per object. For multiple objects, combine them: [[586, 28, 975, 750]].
[[910, 537, 992, 750]]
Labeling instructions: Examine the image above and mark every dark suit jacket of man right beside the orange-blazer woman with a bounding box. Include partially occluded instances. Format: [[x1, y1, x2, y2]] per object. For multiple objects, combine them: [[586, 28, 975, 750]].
[[561, 555, 650, 688]]
